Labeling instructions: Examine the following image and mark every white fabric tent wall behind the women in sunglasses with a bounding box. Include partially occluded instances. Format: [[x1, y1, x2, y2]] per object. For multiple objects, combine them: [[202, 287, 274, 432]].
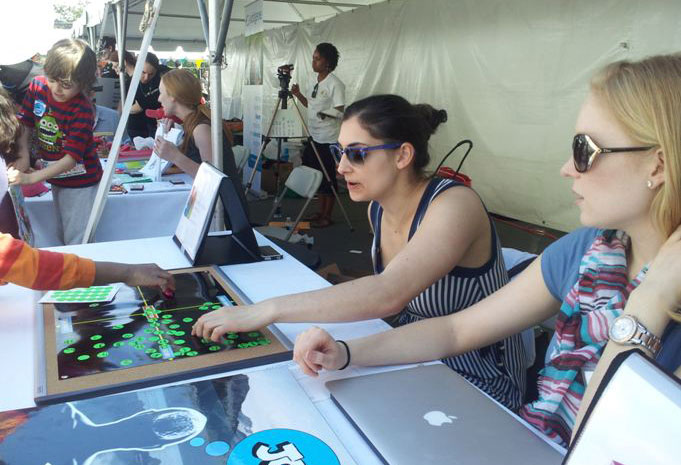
[[223, 0, 681, 230]]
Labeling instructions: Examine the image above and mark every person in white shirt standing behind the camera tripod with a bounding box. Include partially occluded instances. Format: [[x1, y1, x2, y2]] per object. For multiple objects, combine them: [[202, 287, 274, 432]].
[[291, 43, 345, 228]]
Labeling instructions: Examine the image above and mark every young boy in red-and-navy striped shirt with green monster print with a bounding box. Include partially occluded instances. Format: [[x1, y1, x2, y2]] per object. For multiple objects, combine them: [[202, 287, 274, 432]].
[[7, 39, 102, 245]]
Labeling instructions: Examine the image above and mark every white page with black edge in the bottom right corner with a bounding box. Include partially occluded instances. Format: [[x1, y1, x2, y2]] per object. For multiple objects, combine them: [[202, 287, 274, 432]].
[[565, 349, 681, 465]]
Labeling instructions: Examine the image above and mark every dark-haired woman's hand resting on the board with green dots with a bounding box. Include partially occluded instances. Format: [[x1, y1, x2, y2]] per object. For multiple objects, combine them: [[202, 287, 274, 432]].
[[192, 305, 273, 342]]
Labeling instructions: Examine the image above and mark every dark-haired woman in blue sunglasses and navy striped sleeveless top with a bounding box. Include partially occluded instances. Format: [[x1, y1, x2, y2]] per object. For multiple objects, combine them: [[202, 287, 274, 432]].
[[193, 95, 525, 408]]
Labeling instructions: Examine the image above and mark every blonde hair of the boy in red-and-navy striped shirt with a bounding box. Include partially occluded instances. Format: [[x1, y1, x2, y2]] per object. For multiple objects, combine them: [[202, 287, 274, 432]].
[[44, 39, 97, 91]]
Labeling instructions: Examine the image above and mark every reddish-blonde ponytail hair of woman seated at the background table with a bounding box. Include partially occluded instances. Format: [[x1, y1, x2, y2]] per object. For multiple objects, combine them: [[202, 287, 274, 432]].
[[161, 69, 210, 153]]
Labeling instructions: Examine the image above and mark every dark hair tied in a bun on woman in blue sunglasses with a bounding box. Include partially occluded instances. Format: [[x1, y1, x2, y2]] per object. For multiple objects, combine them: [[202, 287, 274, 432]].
[[343, 94, 447, 174]]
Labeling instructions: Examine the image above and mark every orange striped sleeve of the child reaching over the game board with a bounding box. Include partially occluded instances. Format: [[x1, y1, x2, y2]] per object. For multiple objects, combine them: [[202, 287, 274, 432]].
[[0, 234, 95, 290]]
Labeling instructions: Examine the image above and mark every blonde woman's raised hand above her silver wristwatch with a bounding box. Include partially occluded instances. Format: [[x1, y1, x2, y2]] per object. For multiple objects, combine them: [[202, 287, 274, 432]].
[[634, 226, 681, 311]]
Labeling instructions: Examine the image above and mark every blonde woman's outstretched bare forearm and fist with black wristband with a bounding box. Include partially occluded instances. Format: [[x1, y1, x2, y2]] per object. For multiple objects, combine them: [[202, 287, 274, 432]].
[[293, 257, 558, 376]]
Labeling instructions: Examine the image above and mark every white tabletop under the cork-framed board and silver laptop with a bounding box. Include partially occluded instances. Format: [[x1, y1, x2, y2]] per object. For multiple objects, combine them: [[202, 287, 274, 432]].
[[0, 234, 390, 465]]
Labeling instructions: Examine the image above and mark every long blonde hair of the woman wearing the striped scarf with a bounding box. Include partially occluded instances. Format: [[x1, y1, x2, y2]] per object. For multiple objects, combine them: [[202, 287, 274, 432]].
[[591, 54, 681, 321]]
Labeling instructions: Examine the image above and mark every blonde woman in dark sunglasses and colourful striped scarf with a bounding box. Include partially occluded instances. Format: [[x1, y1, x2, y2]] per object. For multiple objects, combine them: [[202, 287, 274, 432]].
[[294, 56, 681, 446]]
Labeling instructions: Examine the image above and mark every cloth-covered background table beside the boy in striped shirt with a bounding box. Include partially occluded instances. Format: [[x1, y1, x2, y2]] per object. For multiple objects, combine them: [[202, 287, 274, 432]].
[[24, 174, 193, 247]]
